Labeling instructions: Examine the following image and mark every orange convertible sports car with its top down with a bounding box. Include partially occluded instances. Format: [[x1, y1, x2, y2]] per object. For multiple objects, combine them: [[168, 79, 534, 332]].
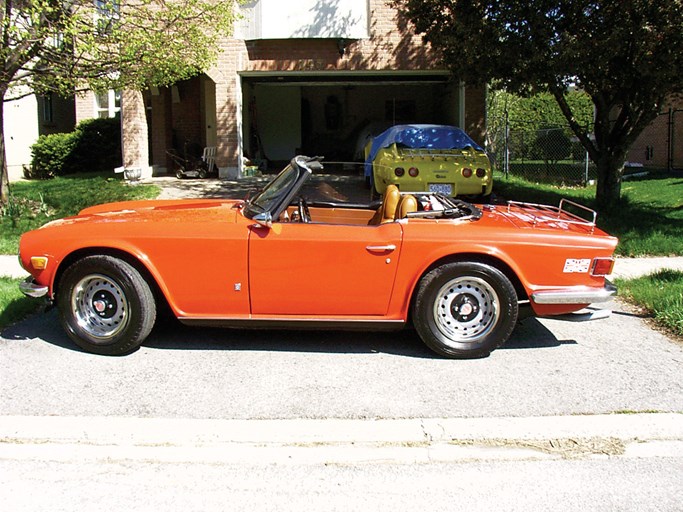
[[20, 156, 617, 358]]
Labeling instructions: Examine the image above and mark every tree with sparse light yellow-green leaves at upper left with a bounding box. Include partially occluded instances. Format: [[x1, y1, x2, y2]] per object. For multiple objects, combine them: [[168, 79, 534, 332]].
[[0, 0, 236, 204]]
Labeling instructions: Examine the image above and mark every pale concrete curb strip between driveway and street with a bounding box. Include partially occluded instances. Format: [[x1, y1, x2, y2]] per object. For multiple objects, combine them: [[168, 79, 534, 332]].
[[0, 413, 683, 464]]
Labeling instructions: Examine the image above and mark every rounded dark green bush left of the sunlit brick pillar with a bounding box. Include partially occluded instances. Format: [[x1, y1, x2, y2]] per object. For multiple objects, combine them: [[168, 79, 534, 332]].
[[29, 118, 121, 179]]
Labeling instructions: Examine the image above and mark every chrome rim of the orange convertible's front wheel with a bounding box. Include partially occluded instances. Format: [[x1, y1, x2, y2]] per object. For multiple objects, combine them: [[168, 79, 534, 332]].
[[71, 274, 130, 343]]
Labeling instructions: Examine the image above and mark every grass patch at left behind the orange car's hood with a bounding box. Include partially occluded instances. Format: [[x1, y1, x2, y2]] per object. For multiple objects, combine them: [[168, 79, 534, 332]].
[[0, 173, 159, 254]]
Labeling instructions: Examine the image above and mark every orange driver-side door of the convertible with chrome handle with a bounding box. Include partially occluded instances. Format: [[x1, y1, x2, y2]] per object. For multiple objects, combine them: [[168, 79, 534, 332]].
[[249, 223, 402, 317]]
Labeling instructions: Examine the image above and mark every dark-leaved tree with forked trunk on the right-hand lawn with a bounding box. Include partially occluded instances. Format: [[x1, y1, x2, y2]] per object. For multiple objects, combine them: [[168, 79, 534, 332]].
[[392, 0, 683, 208]]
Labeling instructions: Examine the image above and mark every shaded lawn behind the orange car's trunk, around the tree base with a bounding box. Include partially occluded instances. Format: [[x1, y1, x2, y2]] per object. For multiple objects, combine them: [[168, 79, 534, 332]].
[[493, 174, 683, 256]]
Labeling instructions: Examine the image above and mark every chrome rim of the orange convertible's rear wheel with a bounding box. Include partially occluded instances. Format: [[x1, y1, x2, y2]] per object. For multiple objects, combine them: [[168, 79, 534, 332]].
[[434, 276, 500, 343]]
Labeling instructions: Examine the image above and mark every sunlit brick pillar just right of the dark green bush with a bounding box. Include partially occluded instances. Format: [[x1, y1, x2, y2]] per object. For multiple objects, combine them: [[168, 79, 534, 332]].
[[121, 89, 149, 172]]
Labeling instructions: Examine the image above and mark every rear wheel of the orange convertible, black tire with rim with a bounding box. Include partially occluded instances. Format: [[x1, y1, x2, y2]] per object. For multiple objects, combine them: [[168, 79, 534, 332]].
[[413, 262, 518, 359]]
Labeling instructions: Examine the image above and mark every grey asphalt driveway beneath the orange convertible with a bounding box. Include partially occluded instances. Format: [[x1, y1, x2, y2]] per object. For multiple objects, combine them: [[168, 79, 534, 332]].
[[0, 296, 683, 419]]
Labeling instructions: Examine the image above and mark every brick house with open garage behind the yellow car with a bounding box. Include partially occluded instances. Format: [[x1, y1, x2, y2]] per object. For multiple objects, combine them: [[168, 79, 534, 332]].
[[76, 0, 485, 176]]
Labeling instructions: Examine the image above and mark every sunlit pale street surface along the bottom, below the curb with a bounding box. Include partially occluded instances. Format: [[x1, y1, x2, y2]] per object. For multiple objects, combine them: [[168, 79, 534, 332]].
[[0, 458, 683, 512]]
